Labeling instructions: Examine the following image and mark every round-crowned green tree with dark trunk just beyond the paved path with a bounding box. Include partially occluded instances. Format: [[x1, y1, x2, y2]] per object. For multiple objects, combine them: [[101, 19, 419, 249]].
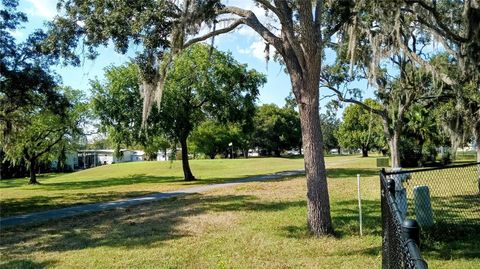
[[160, 44, 266, 180]]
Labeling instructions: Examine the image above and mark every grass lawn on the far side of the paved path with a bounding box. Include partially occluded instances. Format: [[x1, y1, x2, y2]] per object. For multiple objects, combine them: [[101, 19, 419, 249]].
[[0, 156, 366, 217]]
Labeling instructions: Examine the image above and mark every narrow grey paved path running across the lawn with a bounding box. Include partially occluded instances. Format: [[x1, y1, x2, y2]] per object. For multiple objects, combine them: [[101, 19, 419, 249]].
[[0, 170, 305, 229]]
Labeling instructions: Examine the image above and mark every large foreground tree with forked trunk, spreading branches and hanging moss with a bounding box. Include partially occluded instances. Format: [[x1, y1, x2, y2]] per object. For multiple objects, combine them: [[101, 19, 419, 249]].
[[47, 0, 353, 235]]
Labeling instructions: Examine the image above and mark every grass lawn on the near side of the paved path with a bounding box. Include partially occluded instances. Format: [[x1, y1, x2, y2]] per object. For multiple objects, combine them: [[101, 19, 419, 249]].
[[0, 158, 480, 268]]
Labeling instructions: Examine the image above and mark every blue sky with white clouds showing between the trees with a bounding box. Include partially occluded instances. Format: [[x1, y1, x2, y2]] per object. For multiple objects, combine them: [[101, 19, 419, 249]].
[[13, 0, 371, 112]]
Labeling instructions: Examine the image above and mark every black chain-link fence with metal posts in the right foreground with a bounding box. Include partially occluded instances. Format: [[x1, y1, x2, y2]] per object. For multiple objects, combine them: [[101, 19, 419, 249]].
[[380, 163, 480, 268]]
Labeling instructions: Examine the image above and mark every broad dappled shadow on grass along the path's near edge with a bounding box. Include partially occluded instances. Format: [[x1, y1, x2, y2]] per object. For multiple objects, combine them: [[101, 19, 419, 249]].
[[0, 194, 305, 255]]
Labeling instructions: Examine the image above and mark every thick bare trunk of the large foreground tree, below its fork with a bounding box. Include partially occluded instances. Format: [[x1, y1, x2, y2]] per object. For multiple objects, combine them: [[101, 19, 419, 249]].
[[292, 86, 333, 235]]
